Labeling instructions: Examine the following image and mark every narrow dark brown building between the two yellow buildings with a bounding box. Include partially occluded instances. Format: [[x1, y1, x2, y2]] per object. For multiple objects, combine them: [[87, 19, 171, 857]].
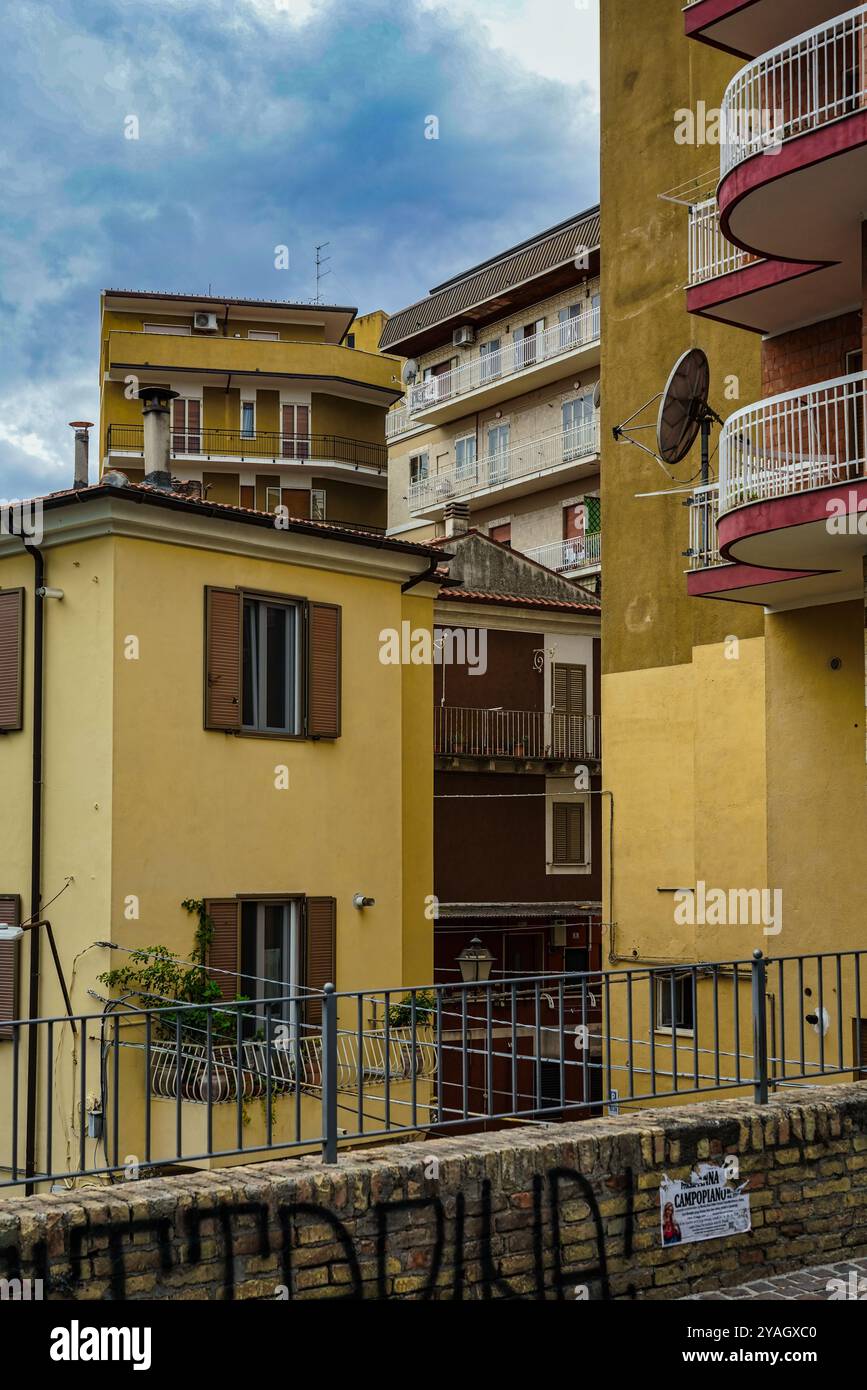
[[434, 530, 603, 1119]]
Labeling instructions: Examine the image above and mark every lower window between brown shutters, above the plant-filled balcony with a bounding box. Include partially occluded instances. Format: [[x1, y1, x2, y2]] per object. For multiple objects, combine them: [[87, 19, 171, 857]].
[[238, 902, 300, 1036]]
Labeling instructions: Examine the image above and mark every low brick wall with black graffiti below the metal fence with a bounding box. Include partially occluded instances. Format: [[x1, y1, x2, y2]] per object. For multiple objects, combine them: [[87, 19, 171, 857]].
[[0, 1086, 867, 1300]]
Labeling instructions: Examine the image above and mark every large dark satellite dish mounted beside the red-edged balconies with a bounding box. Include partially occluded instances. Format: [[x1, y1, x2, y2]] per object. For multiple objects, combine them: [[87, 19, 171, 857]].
[[611, 348, 723, 487]]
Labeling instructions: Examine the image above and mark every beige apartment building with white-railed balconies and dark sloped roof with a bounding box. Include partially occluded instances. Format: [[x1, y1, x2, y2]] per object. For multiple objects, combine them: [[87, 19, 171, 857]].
[[379, 207, 602, 588]]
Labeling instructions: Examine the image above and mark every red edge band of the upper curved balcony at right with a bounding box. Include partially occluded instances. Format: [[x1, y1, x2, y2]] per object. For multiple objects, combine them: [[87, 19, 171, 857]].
[[717, 108, 867, 261]]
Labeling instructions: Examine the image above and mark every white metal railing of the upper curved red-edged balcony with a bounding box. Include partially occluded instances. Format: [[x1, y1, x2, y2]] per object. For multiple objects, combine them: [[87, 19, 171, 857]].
[[720, 6, 867, 178]]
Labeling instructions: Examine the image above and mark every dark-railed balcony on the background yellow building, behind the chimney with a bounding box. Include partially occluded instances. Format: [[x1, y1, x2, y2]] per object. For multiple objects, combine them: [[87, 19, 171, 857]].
[[107, 425, 388, 481]]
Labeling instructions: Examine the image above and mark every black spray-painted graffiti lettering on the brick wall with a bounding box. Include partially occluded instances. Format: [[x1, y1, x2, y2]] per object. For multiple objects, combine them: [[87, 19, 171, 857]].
[[0, 1168, 635, 1301]]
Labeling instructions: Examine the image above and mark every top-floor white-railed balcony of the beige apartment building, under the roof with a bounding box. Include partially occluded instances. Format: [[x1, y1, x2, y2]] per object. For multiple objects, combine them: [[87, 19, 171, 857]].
[[408, 307, 599, 425]]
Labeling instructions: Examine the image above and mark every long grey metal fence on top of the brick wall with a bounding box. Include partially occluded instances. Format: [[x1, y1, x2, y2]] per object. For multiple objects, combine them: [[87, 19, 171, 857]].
[[0, 952, 867, 1187]]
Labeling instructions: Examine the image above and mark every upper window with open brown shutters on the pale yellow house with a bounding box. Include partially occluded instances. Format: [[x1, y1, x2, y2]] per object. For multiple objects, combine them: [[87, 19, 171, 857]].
[[204, 588, 342, 738]]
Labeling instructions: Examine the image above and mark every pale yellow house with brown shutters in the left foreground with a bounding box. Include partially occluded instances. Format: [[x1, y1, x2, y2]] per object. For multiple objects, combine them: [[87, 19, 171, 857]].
[[0, 472, 436, 1180]]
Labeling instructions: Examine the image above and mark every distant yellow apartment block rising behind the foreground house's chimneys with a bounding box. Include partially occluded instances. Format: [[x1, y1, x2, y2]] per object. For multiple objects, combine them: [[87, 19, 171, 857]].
[[99, 289, 403, 530]]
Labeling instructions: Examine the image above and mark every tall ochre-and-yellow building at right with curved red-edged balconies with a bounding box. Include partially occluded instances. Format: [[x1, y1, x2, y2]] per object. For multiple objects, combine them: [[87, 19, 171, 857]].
[[602, 0, 867, 1090]]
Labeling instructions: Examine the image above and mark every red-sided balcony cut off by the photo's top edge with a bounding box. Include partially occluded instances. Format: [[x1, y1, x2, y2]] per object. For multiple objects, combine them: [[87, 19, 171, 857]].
[[684, 0, 839, 58]]
